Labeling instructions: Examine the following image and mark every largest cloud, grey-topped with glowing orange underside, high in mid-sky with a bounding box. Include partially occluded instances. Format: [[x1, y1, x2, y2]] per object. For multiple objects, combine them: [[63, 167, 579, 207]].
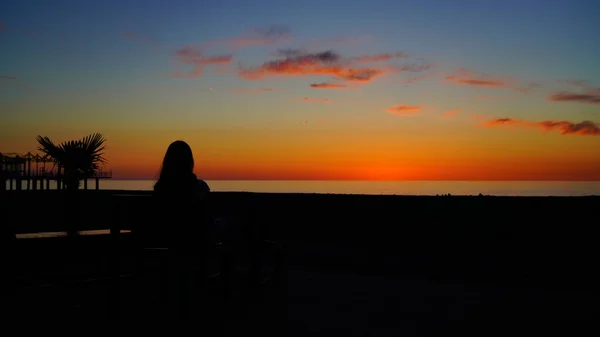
[[239, 49, 394, 83]]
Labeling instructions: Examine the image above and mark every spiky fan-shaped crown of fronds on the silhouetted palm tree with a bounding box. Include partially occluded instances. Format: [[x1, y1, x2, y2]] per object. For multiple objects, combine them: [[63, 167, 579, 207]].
[[37, 133, 106, 191]]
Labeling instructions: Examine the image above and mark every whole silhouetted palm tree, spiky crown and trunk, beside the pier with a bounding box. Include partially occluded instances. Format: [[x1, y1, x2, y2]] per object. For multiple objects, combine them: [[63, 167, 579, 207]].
[[37, 133, 106, 237]]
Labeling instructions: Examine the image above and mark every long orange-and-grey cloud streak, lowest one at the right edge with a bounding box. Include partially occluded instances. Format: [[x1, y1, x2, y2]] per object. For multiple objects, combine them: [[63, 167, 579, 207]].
[[483, 118, 600, 136]]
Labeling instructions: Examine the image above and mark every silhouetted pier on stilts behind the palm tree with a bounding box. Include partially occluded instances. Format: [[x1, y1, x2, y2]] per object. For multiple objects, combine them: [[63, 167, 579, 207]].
[[0, 152, 112, 191]]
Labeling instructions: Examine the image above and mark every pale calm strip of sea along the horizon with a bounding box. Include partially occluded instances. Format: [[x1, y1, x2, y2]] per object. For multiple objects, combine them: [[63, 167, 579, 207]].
[[7, 179, 600, 196]]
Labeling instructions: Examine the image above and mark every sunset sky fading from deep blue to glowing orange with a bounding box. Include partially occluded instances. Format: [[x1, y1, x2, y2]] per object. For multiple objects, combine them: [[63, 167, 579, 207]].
[[0, 0, 600, 180]]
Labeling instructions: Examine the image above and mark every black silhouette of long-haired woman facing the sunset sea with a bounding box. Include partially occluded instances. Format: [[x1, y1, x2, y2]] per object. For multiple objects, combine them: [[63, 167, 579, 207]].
[[142, 140, 211, 316]]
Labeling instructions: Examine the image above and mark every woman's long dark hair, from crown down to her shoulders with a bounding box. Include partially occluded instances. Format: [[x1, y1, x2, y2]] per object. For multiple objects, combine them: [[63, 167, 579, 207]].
[[154, 140, 197, 194]]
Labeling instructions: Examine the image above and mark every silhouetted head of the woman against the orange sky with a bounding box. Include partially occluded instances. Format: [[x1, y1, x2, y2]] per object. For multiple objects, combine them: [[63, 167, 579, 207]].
[[159, 140, 194, 179]]
